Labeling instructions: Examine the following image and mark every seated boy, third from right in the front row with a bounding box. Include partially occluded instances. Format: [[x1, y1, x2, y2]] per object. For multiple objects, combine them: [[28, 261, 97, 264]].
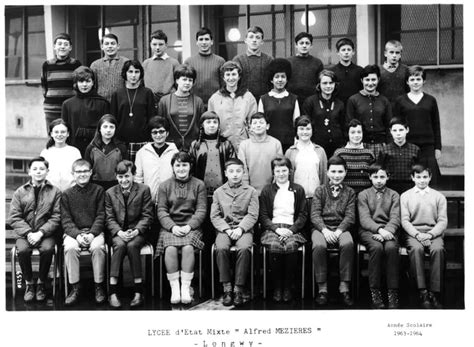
[[311, 156, 356, 306]]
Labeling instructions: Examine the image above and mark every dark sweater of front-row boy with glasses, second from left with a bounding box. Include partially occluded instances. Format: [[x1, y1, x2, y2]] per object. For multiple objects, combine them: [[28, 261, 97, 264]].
[[61, 183, 105, 238]]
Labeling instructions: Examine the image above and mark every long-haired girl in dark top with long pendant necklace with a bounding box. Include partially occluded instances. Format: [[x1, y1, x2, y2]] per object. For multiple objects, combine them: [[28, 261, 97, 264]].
[[110, 60, 156, 162]]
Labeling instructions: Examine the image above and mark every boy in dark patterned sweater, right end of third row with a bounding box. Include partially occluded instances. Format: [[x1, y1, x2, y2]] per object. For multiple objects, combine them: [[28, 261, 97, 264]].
[[378, 117, 420, 194]]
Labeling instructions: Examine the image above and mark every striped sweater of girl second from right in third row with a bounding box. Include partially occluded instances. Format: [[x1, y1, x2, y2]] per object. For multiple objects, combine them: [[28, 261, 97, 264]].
[[334, 147, 375, 193]]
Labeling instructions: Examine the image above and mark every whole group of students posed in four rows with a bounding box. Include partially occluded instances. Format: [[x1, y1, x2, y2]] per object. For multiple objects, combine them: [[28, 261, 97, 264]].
[[9, 27, 446, 308]]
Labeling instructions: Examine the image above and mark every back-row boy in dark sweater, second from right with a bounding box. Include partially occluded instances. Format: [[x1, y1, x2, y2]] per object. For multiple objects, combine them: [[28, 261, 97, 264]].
[[329, 37, 362, 105]]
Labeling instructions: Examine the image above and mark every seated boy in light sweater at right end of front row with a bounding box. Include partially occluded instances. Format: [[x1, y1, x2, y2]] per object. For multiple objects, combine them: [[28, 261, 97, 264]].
[[400, 164, 448, 308]]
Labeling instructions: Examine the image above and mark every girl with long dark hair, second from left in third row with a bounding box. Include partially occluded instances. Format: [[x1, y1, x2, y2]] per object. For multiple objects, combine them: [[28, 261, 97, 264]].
[[84, 114, 127, 190]]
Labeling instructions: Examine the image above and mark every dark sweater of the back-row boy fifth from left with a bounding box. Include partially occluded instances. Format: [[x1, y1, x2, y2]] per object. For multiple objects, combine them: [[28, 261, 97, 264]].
[[233, 52, 273, 102]]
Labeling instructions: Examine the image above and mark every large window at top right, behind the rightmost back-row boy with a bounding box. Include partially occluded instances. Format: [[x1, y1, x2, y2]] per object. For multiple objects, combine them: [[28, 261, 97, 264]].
[[381, 5, 463, 66]]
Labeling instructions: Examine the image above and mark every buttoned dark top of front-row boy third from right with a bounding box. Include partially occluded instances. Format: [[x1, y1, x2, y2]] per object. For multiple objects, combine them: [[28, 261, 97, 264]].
[[311, 183, 356, 231]]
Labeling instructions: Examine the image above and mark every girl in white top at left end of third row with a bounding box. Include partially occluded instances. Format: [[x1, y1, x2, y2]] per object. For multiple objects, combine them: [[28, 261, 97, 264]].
[[40, 118, 81, 191]]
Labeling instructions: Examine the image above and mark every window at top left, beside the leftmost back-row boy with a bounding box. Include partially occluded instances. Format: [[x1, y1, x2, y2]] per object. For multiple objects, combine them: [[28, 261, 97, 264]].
[[5, 6, 46, 80]]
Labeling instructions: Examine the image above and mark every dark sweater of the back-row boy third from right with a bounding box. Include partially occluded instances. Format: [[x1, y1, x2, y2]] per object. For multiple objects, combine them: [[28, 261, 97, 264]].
[[286, 55, 324, 105]]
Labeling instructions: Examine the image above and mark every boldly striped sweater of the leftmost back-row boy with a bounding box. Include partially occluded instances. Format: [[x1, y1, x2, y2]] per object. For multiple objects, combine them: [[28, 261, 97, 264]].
[[41, 57, 81, 118]]
